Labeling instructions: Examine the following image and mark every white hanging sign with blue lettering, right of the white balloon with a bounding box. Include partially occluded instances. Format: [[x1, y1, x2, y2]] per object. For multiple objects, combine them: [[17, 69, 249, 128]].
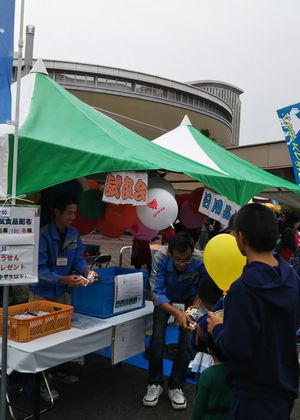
[[198, 188, 241, 226]]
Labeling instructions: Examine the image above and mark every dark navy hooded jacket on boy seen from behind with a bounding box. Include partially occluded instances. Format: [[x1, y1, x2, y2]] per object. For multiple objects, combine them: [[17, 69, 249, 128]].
[[213, 256, 300, 400]]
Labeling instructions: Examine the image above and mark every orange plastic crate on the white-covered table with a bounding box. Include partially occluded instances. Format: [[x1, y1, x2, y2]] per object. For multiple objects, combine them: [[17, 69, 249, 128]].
[[0, 300, 74, 342]]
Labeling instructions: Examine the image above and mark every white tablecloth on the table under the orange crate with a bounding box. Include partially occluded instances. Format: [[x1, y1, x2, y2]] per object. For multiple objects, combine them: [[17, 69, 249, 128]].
[[0, 301, 153, 373]]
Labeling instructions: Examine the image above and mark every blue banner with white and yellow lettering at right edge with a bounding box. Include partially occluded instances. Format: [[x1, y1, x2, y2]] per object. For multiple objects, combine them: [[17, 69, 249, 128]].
[[277, 103, 300, 185]]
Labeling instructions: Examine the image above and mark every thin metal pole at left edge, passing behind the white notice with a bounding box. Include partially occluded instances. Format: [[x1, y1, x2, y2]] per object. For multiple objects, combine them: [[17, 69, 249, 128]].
[[0, 0, 24, 420]]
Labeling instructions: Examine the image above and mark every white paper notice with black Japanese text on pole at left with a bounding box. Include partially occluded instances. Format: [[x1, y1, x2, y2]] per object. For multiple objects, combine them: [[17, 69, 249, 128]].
[[0, 206, 40, 286]]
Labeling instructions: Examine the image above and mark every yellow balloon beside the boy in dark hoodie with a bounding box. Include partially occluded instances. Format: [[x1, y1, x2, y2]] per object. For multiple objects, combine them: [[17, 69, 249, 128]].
[[203, 233, 246, 292]]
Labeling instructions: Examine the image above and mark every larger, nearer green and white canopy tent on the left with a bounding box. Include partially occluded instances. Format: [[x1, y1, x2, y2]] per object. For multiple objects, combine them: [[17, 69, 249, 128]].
[[0, 61, 244, 203]]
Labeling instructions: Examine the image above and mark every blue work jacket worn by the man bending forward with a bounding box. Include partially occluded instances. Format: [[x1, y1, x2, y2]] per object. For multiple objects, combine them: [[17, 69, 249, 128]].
[[150, 247, 206, 306]]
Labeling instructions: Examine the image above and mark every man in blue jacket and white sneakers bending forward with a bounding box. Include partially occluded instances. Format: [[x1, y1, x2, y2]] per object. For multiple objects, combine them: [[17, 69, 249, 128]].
[[143, 232, 205, 409]]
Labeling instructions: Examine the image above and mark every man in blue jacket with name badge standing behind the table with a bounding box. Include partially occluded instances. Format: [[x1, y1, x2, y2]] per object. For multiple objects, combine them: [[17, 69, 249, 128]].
[[29, 193, 95, 303]]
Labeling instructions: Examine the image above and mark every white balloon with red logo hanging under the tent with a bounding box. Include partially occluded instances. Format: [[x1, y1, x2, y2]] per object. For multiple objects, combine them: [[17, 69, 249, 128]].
[[137, 188, 178, 230]]
